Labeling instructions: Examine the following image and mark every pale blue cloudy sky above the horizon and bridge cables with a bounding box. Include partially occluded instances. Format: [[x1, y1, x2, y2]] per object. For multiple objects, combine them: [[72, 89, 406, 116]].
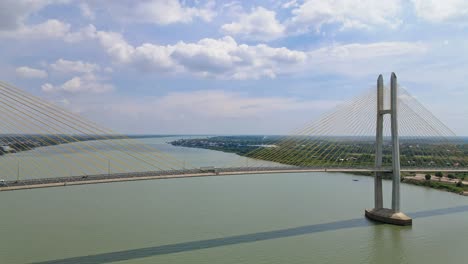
[[0, 0, 468, 136]]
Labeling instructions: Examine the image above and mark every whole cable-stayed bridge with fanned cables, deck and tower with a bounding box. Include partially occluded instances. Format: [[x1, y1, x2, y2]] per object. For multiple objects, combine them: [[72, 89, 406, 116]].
[[0, 74, 468, 225]]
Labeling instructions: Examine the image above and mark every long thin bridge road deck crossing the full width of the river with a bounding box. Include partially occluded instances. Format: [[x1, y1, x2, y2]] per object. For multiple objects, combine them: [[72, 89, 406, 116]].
[[0, 166, 468, 191]]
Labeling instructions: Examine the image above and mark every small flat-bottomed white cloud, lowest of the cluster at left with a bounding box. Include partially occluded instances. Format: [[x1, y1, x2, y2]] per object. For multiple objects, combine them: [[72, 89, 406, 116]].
[[41, 73, 114, 94]]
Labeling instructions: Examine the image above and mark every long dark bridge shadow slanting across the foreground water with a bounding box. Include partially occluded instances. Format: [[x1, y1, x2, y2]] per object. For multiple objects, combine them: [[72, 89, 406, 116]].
[[35, 206, 468, 264]]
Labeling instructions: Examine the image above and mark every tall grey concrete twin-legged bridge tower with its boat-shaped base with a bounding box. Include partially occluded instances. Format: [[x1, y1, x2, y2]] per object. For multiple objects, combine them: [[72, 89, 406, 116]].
[[365, 73, 412, 225]]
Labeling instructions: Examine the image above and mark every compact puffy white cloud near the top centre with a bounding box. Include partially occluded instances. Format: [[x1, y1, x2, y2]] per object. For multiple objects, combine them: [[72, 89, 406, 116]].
[[221, 7, 285, 41]]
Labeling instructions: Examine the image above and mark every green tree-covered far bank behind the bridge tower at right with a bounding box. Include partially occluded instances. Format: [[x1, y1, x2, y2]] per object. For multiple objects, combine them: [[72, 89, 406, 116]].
[[171, 136, 468, 167]]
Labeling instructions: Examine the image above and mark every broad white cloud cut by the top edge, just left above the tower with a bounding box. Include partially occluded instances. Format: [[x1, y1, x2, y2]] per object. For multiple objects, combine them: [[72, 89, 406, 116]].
[[288, 0, 402, 31]]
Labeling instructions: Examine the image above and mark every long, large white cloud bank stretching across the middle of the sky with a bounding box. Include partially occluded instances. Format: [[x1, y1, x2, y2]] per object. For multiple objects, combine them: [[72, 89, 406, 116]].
[[92, 31, 306, 79]]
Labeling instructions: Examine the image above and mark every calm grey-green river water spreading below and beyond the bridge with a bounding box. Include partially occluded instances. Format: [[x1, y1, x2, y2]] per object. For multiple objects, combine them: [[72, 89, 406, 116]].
[[0, 138, 468, 264]]
